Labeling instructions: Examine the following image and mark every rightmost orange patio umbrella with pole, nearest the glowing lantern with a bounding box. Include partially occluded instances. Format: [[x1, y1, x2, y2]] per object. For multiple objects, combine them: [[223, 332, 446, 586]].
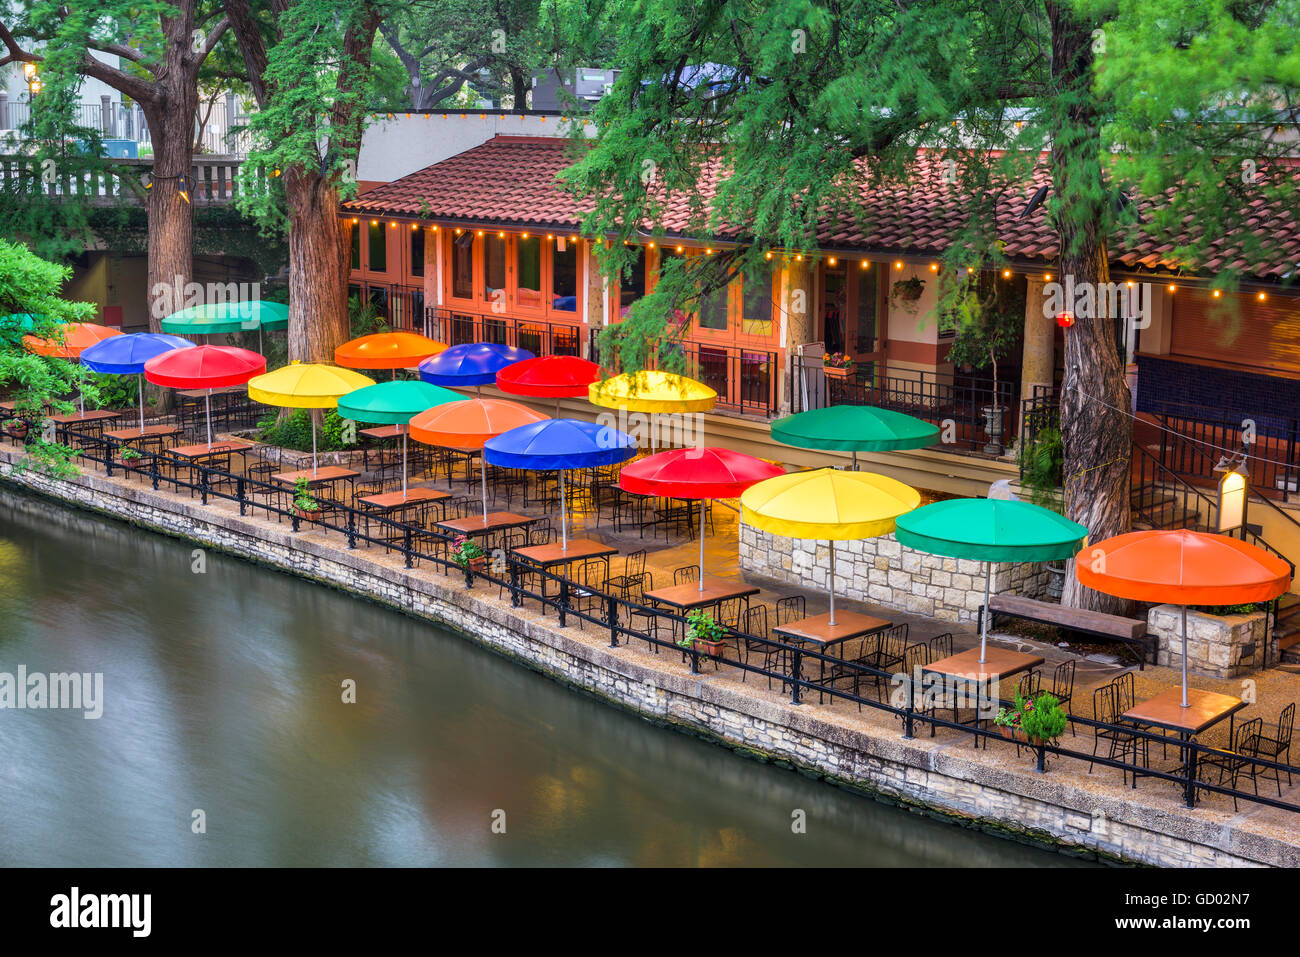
[[1074, 528, 1292, 707]]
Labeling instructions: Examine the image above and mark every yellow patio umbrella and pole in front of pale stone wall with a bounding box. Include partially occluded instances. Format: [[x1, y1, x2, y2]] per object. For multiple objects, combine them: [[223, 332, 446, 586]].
[[740, 468, 920, 624]]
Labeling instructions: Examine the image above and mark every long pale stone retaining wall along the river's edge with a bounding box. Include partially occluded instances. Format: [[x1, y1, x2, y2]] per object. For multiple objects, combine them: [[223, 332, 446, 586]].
[[0, 460, 1300, 866]]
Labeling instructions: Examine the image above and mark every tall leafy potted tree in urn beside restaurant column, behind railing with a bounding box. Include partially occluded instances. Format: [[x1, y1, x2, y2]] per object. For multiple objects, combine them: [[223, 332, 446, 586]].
[[941, 273, 1024, 455]]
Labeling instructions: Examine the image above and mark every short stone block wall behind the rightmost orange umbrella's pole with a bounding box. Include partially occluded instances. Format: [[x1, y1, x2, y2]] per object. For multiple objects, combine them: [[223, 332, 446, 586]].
[[1147, 605, 1278, 677]]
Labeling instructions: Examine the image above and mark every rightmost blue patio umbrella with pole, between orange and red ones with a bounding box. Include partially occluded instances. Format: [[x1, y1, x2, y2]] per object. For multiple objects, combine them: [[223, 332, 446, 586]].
[[484, 419, 637, 549]]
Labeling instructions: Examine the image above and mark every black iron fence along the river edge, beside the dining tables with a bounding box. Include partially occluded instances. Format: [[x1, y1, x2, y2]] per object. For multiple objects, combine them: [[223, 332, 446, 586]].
[[15, 428, 1300, 811]]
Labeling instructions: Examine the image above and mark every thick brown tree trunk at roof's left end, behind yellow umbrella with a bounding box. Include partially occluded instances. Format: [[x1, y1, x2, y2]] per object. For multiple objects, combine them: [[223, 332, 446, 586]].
[[285, 166, 351, 363]]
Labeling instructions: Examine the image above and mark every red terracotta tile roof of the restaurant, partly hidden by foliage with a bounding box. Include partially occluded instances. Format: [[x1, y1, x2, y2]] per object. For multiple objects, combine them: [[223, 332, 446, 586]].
[[343, 137, 1300, 280]]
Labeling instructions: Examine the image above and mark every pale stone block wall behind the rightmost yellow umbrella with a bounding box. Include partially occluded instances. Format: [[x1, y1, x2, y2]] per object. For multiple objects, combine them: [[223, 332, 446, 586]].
[[740, 524, 1052, 622]]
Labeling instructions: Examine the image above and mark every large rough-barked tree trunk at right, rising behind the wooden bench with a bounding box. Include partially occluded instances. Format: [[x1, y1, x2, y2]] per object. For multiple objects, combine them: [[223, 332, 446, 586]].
[[1048, 3, 1132, 614]]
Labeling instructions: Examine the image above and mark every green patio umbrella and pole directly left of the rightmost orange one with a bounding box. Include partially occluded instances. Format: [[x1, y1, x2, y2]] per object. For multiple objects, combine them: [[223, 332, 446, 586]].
[[894, 498, 1088, 662]]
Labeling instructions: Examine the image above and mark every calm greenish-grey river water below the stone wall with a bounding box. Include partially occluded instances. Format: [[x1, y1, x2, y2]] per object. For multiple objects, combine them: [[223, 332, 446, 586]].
[[0, 490, 1074, 866]]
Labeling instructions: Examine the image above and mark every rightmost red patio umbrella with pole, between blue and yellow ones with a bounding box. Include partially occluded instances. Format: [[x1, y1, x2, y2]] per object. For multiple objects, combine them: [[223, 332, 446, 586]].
[[619, 449, 785, 592]]
